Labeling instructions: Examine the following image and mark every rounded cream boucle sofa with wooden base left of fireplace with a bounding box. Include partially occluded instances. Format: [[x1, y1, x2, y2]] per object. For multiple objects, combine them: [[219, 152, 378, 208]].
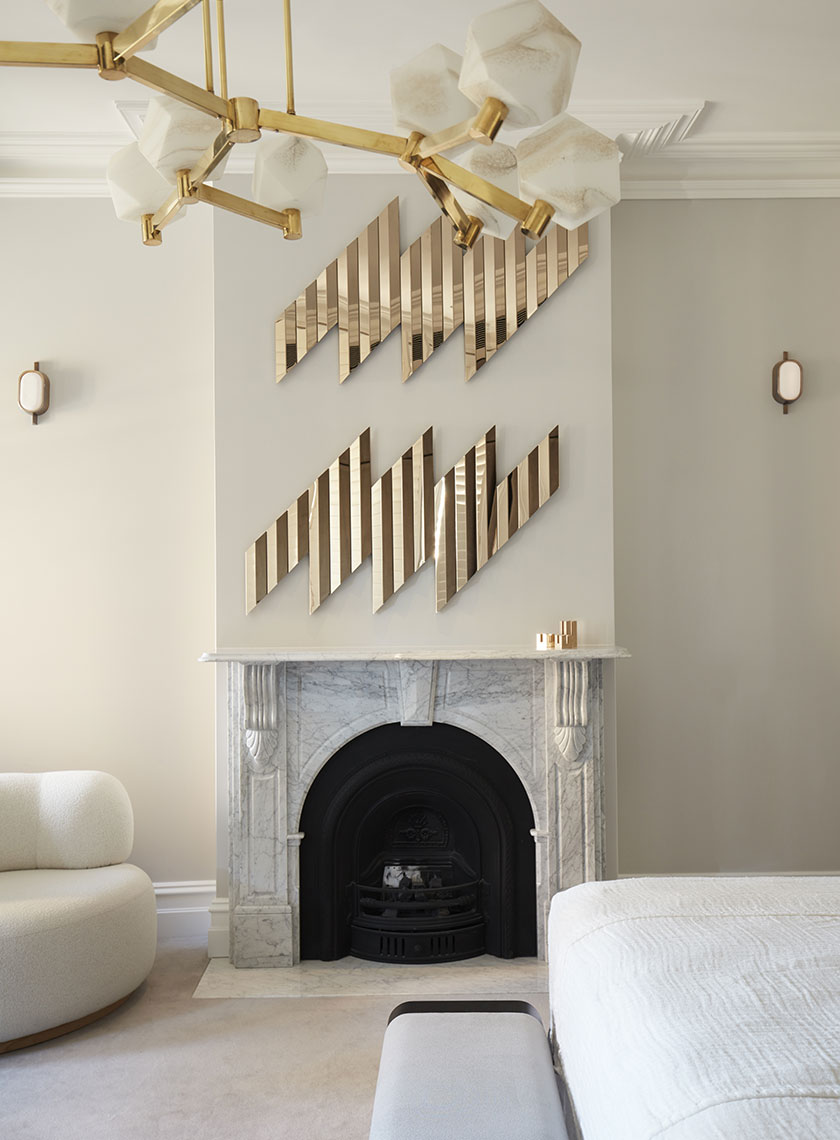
[[0, 772, 157, 1052]]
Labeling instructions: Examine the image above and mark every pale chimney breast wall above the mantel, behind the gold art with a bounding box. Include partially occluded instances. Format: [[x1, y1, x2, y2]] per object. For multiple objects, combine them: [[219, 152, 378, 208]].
[[215, 174, 613, 649]]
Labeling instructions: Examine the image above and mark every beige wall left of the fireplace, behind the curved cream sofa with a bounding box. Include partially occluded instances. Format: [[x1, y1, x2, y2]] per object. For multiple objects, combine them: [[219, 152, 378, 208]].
[[0, 200, 215, 881]]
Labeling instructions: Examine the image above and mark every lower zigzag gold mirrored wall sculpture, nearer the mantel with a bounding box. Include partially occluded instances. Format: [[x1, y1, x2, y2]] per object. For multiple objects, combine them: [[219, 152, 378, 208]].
[[245, 426, 560, 613]]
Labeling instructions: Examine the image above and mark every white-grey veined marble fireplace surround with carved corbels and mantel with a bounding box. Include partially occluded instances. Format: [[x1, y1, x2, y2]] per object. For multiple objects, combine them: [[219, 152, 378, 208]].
[[202, 645, 629, 967]]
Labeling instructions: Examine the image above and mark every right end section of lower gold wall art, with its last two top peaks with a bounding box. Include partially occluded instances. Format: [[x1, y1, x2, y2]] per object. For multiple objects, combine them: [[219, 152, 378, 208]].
[[434, 426, 560, 612]]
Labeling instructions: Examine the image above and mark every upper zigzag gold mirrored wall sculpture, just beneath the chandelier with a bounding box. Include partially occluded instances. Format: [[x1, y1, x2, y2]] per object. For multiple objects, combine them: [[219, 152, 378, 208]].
[[275, 198, 589, 383]]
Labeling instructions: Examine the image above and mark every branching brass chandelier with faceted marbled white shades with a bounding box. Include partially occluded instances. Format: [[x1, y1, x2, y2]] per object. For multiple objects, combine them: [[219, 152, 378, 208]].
[[0, 0, 621, 249]]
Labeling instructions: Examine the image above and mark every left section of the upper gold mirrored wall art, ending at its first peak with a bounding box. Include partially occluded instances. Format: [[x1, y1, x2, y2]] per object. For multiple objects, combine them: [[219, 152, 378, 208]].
[[275, 198, 400, 383]]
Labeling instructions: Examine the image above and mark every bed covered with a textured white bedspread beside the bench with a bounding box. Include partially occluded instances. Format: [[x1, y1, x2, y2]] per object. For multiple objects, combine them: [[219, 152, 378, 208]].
[[548, 878, 840, 1140]]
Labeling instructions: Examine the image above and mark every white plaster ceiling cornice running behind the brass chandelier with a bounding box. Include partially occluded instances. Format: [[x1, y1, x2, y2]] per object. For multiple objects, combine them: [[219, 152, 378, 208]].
[[0, 99, 840, 200]]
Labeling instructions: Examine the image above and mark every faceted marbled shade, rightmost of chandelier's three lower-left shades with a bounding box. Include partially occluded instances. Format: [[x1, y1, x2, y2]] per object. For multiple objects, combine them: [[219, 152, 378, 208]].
[[253, 135, 327, 214]]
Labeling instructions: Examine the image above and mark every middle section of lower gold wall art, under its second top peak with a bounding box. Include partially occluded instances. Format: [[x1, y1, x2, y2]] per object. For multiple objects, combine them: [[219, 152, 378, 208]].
[[370, 428, 434, 613]]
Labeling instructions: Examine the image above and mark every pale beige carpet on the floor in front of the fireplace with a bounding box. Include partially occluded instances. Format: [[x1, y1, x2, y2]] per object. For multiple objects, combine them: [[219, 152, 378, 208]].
[[0, 942, 548, 1140]]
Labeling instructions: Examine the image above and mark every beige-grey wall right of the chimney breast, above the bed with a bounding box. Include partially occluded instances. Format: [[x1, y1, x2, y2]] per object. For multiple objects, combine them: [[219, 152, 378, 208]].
[[613, 200, 840, 873]]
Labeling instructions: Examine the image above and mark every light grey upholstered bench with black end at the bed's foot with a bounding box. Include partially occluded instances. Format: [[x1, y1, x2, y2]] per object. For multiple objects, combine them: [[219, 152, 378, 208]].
[[370, 1001, 568, 1140]]
